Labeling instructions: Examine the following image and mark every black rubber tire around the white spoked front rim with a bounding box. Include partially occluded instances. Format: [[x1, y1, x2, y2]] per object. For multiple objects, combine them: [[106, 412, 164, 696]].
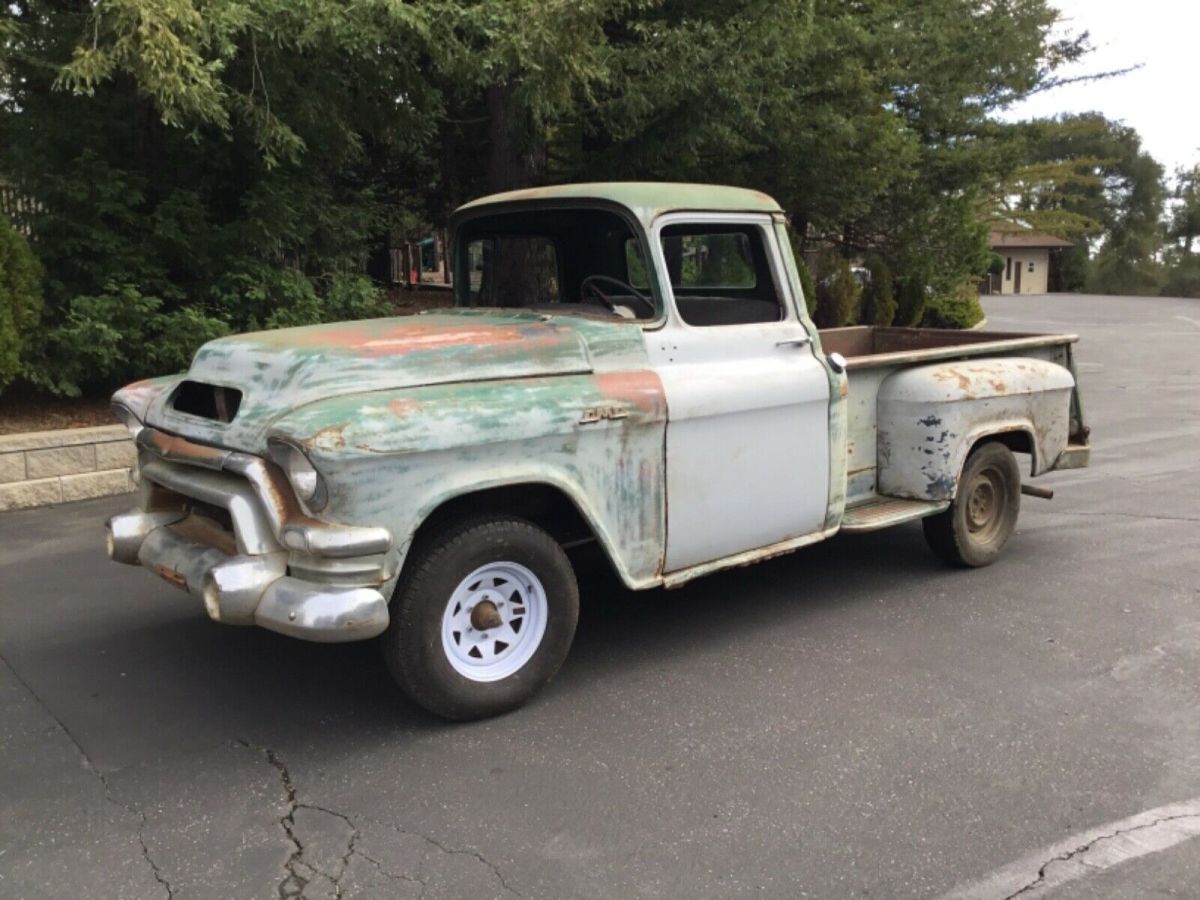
[[380, 516, 580, 720]]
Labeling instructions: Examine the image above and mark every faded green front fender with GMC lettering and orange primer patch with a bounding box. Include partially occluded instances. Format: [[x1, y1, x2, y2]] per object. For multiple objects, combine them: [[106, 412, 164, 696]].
[[270, 371, 666, 587]]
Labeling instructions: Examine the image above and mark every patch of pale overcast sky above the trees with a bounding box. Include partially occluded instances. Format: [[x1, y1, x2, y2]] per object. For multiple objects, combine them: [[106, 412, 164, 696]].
[[1008, 0, 1200, 175]]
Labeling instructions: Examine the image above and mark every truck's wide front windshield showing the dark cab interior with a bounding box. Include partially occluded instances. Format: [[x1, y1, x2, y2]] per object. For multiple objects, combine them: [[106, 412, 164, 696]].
[[455, 209, 658, 320]]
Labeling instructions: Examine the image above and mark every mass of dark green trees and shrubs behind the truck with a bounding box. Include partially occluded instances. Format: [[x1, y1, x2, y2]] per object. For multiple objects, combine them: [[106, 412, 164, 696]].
[[0, 0, 1180, 395]]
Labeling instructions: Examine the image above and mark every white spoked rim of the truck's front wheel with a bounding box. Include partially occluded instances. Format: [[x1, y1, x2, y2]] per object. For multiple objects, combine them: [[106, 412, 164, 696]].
[[442, 562, 548, 682]]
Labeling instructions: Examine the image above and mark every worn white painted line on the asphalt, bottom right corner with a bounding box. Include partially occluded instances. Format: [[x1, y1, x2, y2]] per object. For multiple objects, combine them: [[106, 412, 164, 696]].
[[941, 797, 1200, 900]]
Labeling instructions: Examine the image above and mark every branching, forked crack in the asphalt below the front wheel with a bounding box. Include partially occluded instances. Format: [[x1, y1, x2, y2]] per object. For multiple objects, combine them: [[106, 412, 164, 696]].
[[236, 738, 521, 900]]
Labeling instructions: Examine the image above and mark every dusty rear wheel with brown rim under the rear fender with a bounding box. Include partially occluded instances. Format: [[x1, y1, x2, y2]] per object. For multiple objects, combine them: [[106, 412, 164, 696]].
[[923, 440, 1021, 568]]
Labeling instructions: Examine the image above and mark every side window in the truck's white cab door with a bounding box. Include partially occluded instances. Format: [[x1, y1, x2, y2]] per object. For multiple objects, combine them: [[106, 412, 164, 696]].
[[662, 223, 784, 326]]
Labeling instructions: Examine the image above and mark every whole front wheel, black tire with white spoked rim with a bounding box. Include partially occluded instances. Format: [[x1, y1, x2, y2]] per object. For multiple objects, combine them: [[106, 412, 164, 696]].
[[382, 516, 580, 720]]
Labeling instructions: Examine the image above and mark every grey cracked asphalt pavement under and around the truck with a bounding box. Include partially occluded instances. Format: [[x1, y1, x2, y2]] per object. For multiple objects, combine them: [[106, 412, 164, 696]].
[[0, 295, 1200, 899]]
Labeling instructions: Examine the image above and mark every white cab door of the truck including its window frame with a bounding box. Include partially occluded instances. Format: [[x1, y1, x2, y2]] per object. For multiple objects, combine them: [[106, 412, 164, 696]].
[[646, 215, 829, 572]]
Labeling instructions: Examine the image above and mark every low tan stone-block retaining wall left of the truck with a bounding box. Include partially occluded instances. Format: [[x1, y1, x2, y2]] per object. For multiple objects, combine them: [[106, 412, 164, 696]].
[[0, 425, 137, 512]]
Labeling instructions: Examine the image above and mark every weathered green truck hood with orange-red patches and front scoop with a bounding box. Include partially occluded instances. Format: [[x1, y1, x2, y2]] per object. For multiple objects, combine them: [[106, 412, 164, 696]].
[[146, 311, 641, 452]]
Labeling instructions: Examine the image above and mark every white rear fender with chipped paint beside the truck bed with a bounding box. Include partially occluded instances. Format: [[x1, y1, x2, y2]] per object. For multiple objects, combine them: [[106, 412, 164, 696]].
[[877, 356, 1075, 500]]
